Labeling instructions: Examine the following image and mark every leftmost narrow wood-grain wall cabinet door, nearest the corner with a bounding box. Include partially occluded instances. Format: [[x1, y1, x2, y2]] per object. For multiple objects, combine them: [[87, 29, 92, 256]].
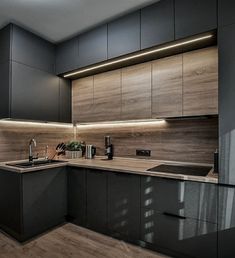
[[72, 76, 94, 122]]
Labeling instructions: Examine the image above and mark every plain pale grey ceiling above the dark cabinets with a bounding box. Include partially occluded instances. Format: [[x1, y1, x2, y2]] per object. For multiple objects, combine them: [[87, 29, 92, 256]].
[[0, 0, 158, 42]]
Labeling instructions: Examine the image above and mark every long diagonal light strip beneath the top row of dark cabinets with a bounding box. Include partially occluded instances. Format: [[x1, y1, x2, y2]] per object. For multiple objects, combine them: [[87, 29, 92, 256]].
[[64, 34, 213, 78]]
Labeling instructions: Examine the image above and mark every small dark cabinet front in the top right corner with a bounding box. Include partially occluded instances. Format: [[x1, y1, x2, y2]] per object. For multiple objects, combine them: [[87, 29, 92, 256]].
[[218, 0, 235, 27]]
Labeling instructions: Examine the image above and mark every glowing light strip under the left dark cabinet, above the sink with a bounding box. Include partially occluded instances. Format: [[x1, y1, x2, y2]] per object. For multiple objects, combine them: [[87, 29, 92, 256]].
[[0, 119, 73, 128]]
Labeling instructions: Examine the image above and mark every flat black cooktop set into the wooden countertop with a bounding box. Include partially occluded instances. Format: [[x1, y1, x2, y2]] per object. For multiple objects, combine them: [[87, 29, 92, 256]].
[[148, 164, 212, 176]]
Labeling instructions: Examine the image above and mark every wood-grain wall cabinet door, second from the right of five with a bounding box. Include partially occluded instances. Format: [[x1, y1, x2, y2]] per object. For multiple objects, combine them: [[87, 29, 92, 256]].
[[152, 55, 183, 118]]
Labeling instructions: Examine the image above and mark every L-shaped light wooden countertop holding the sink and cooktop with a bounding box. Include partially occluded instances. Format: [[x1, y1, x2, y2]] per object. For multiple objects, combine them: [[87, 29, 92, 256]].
[[0, 157, 218, 184]]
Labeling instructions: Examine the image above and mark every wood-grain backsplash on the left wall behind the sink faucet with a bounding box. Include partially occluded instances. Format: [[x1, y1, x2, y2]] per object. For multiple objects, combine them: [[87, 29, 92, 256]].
[[0, 122, 76, 161]]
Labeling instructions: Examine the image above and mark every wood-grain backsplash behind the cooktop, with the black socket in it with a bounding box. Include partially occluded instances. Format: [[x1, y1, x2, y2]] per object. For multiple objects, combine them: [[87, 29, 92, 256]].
[[77, 118, 218, 163]]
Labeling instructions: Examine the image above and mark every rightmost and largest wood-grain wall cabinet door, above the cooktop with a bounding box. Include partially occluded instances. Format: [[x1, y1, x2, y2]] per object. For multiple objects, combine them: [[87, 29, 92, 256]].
[[183, 47, 218, 116]]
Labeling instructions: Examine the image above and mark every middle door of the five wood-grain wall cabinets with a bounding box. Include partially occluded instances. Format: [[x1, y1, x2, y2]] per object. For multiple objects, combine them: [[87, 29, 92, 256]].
[[122, 63, 151, 119]]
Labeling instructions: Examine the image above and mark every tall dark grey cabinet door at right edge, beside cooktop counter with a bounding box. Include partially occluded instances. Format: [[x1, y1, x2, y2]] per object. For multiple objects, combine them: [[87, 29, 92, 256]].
[[218, 24, 235, 185]]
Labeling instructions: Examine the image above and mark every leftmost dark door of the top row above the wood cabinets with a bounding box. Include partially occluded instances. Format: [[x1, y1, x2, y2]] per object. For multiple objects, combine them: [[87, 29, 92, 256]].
[[56, 37, 78, 74]]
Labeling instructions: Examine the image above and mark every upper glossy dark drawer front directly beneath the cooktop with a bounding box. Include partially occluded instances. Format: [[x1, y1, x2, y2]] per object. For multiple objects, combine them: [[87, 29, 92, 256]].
[[141, 177, 217, 224]]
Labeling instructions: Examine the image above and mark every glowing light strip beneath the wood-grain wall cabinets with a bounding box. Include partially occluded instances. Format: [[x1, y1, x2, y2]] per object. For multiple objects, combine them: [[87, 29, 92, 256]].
[[76, 119, 166, 129]]
